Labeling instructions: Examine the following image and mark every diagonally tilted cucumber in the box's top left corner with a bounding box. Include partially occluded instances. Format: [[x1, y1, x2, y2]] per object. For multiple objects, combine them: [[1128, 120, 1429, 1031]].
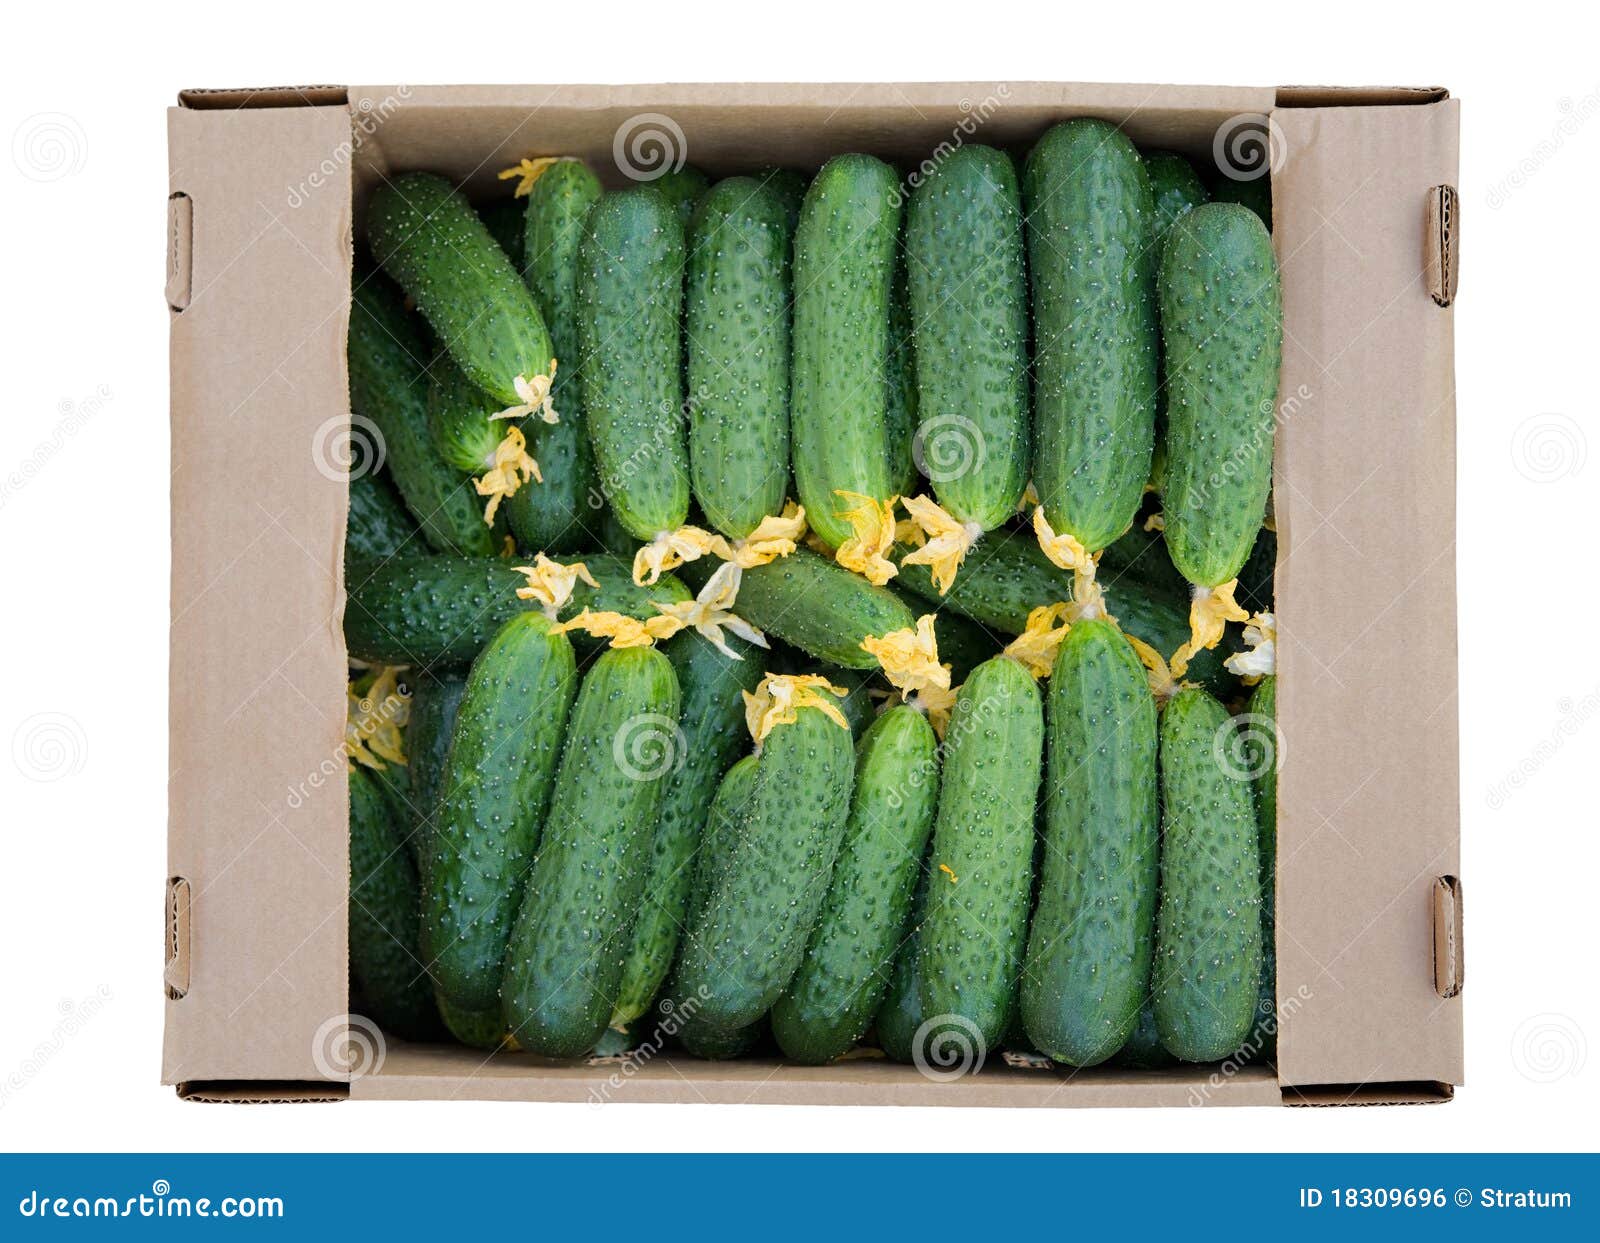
[[366, 173, 555, 406]]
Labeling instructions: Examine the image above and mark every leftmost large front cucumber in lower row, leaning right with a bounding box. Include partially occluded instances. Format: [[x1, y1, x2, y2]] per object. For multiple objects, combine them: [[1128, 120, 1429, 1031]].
[[422, 613, 578, 1009]]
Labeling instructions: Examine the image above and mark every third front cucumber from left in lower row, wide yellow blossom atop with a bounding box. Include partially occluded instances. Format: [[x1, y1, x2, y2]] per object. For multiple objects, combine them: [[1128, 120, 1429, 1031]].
[[678, 707, 853, 1030]]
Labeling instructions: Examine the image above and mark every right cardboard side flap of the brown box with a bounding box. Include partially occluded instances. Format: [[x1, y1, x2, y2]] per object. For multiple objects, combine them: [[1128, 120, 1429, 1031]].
[[1274, 101, 1462, 1085]]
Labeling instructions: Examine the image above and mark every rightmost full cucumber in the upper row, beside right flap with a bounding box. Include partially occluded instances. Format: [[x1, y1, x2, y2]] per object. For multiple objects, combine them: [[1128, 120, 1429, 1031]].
[[1162, 203, 1283, 587]]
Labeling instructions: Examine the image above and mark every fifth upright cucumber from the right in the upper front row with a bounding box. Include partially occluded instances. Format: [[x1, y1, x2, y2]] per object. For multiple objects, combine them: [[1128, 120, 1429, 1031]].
[[685, 178, 789, 539]]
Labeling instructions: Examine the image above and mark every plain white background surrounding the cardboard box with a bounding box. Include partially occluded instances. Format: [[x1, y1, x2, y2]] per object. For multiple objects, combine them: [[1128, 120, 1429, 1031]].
[[0, 0, 1600, 1150]]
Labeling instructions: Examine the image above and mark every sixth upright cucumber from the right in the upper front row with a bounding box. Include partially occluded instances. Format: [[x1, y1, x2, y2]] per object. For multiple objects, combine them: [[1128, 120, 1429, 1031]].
[[578, 187, 690, 541]]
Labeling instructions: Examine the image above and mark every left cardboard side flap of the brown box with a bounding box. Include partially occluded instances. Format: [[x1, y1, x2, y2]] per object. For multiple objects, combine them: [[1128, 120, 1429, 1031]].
[[164, 107, 350, 1081]]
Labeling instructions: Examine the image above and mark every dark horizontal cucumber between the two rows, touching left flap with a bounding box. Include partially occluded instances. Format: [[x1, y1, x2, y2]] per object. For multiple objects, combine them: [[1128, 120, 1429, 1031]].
[[344, 552, 691, 670]]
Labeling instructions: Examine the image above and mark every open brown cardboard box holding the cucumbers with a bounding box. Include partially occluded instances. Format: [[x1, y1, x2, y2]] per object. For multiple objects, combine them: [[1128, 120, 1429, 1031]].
[[162, 83, 1462, 1105]]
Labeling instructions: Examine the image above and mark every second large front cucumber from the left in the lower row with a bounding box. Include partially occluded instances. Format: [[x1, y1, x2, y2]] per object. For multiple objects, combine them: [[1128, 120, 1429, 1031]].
[[501, 648, 678, 1057]]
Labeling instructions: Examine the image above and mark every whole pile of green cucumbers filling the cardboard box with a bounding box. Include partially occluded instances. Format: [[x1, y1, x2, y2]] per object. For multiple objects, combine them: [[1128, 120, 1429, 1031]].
[[344, 118, 1282, 1069]]
